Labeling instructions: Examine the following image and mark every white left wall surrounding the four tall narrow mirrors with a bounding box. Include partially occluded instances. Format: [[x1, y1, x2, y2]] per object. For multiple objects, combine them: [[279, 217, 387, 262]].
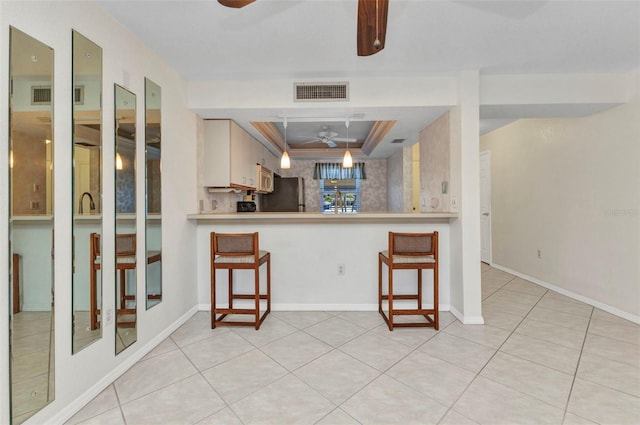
[[0, 1, 197, 423]]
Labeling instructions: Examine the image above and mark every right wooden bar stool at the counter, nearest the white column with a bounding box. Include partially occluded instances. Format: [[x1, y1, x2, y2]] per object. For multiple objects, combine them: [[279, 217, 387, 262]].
[[378, 232, 438, 331]]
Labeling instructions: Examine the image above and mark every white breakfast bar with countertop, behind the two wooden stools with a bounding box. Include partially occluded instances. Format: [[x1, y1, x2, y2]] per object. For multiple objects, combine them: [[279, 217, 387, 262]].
[[188, 212, 458, 311]]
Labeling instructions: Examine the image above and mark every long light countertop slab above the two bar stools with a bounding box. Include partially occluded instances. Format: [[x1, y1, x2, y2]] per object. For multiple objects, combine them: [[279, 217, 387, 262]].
[[187, 212, 458, 224]]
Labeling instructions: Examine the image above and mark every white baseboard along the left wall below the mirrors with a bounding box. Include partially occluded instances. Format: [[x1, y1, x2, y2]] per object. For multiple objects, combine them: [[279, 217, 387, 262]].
[[47, 307, 198, 424]]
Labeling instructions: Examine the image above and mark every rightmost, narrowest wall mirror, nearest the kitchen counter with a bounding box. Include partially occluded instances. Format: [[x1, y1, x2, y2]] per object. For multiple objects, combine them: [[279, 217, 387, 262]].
[[144, 78, 162, 309]]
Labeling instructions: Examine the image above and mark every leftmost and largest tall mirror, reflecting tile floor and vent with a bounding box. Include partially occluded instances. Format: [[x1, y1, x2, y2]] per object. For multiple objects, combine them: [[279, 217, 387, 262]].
[[9, 28, 54, 424]]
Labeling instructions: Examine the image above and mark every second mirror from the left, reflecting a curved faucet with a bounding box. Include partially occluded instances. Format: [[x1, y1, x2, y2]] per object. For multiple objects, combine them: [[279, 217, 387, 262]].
[[72, 31, 102, 353]]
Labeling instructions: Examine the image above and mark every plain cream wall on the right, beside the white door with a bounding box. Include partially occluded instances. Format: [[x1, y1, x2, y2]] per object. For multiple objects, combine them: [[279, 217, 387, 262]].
[[480, 91, 640, 321]]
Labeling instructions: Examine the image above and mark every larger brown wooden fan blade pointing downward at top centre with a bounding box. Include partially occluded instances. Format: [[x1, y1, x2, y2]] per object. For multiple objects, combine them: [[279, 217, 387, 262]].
[[357, 0, 389, 56]]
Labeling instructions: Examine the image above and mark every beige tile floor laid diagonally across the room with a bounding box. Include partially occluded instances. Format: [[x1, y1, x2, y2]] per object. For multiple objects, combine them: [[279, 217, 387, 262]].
[[68, 265, 640, 425]]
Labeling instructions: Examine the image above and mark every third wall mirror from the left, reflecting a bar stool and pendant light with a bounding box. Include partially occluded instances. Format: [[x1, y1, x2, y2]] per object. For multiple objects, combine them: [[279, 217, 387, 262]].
[[114, 84, 136, 354]]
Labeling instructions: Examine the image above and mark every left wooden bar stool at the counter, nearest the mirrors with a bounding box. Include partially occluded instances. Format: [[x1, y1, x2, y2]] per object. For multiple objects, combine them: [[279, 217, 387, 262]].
[[211, 232, 271, 330]]
